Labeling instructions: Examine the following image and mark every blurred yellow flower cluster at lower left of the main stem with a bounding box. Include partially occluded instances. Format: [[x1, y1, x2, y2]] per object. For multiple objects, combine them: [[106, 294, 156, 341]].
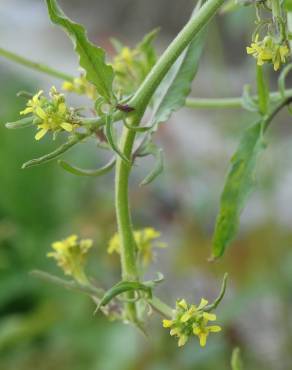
[[47, 235, 93, 284]]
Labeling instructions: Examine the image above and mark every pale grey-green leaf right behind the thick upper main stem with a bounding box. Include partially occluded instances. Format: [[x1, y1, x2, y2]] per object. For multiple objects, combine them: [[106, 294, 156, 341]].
[[152, 22, 207, 125]]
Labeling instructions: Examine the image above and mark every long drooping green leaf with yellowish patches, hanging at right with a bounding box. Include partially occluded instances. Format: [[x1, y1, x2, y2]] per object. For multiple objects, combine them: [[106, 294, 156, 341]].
[[212, 122, 264, 258]]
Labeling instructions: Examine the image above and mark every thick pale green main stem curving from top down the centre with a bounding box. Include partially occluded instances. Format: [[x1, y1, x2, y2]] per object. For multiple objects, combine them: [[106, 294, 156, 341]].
[[115, 0, 224, 322]]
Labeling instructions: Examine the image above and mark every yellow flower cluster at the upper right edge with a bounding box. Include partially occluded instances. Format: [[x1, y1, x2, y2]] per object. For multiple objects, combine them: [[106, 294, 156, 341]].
[[246, 35, 290, 71]]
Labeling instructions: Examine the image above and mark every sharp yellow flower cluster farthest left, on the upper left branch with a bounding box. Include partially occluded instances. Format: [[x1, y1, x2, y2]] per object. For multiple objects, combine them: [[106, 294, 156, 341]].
[[20, 87, 78, 140]]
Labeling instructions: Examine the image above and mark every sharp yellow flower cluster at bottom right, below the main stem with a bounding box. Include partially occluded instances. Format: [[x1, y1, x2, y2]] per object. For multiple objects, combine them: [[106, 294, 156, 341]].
[[163, 298, 221, 347]]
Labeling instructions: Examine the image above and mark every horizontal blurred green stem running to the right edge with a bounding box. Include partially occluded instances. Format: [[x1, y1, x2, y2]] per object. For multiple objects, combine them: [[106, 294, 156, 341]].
[[185, 89, 292, 109]]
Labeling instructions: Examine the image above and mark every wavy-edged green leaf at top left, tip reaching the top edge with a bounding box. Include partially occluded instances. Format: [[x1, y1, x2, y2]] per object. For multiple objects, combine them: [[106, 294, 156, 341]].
[[46, 0, 114, 102]]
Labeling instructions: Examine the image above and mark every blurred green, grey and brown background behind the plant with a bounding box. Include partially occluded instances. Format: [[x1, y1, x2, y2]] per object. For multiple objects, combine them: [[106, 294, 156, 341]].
[[0, 0, 292, 370]]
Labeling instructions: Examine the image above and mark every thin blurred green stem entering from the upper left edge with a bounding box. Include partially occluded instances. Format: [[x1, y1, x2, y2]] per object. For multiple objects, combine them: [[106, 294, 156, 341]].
[[0, 48, 74, 81]]
